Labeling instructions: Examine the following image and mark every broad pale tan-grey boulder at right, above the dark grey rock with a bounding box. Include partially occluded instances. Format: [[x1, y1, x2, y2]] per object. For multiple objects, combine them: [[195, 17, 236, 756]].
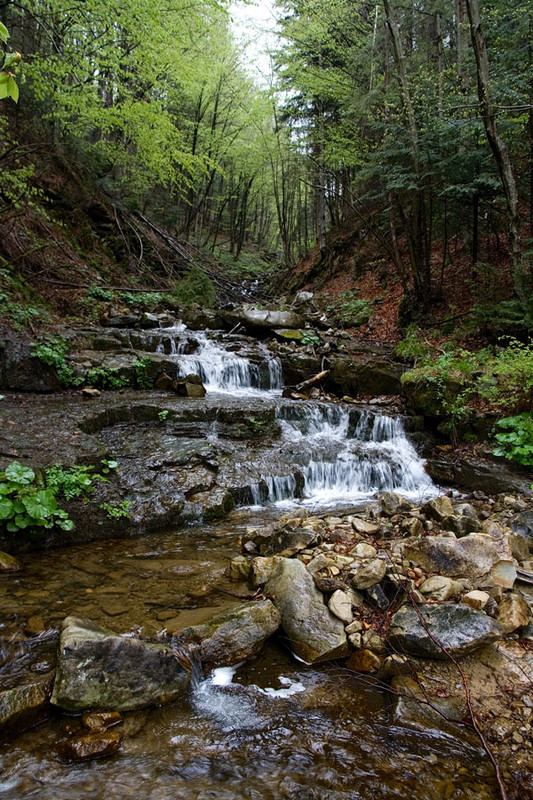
[[404, 533, 516, 589]]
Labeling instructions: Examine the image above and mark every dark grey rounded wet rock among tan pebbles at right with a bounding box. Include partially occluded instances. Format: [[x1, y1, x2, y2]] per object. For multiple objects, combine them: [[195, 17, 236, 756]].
[[389, 603, 504, 659]]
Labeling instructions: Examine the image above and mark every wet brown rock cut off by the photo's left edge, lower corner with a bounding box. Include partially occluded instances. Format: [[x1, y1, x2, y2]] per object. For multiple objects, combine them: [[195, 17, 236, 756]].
[[0, 675, 54, 734]]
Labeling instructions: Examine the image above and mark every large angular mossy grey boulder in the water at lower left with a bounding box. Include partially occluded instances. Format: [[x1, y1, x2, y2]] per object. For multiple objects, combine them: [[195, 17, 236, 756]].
[[51, 617, 190, 711]]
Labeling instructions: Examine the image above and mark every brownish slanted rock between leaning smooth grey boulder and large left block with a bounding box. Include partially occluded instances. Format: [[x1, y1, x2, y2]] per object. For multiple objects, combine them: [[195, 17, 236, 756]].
[[175, 600, 282, 673]]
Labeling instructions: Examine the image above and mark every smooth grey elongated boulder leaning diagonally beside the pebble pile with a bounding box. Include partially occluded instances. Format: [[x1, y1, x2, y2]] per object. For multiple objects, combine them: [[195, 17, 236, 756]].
[[265, 558, 349, 664]]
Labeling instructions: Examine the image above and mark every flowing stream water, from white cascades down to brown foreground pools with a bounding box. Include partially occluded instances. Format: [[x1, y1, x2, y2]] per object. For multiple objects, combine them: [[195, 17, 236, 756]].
[[0, 326, 497, 800]]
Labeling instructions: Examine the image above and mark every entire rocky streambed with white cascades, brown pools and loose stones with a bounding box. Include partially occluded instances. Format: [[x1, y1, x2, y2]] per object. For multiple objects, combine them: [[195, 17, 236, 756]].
[[0, 318, 533, 800]]
